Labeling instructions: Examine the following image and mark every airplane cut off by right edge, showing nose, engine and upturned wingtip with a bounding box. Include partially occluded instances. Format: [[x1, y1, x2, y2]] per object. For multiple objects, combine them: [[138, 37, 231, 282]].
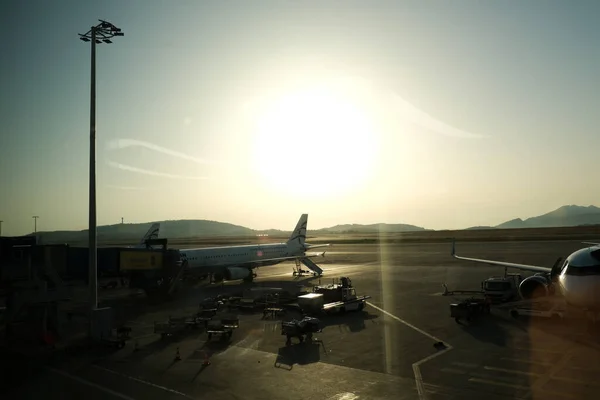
[[451, 241, 600, 312]]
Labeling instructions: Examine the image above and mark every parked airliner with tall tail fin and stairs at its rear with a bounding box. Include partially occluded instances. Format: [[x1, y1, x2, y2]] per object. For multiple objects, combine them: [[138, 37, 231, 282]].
[[179, 214, 329, 282]]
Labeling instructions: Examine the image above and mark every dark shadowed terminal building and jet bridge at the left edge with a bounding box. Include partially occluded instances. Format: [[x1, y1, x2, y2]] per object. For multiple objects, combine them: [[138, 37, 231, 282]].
[[0, 236, 184, 341]]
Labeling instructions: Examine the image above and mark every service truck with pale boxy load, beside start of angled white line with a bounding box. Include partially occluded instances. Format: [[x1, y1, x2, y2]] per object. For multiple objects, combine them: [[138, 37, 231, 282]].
[[298, 277, 371, 314]]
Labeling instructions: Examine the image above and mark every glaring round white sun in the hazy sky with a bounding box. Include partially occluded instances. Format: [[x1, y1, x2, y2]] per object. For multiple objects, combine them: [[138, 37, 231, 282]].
[[253, 86, 377, 196]]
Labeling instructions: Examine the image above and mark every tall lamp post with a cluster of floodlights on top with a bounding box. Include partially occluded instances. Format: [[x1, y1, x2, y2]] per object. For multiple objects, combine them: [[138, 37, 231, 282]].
[[79, 19, 124, 322]]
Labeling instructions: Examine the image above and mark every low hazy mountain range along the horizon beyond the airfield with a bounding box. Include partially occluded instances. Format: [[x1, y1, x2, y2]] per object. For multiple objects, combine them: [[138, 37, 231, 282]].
[[25, 205, 600, 244]]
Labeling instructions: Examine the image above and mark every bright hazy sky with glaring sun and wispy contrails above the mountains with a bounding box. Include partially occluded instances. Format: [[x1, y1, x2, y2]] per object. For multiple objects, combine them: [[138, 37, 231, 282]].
[[0, 0, 600, 235]]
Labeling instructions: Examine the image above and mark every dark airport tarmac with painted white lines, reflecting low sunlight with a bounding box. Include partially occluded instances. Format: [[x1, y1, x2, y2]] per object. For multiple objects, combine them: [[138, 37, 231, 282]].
[[2, 241, 600, 400]]
